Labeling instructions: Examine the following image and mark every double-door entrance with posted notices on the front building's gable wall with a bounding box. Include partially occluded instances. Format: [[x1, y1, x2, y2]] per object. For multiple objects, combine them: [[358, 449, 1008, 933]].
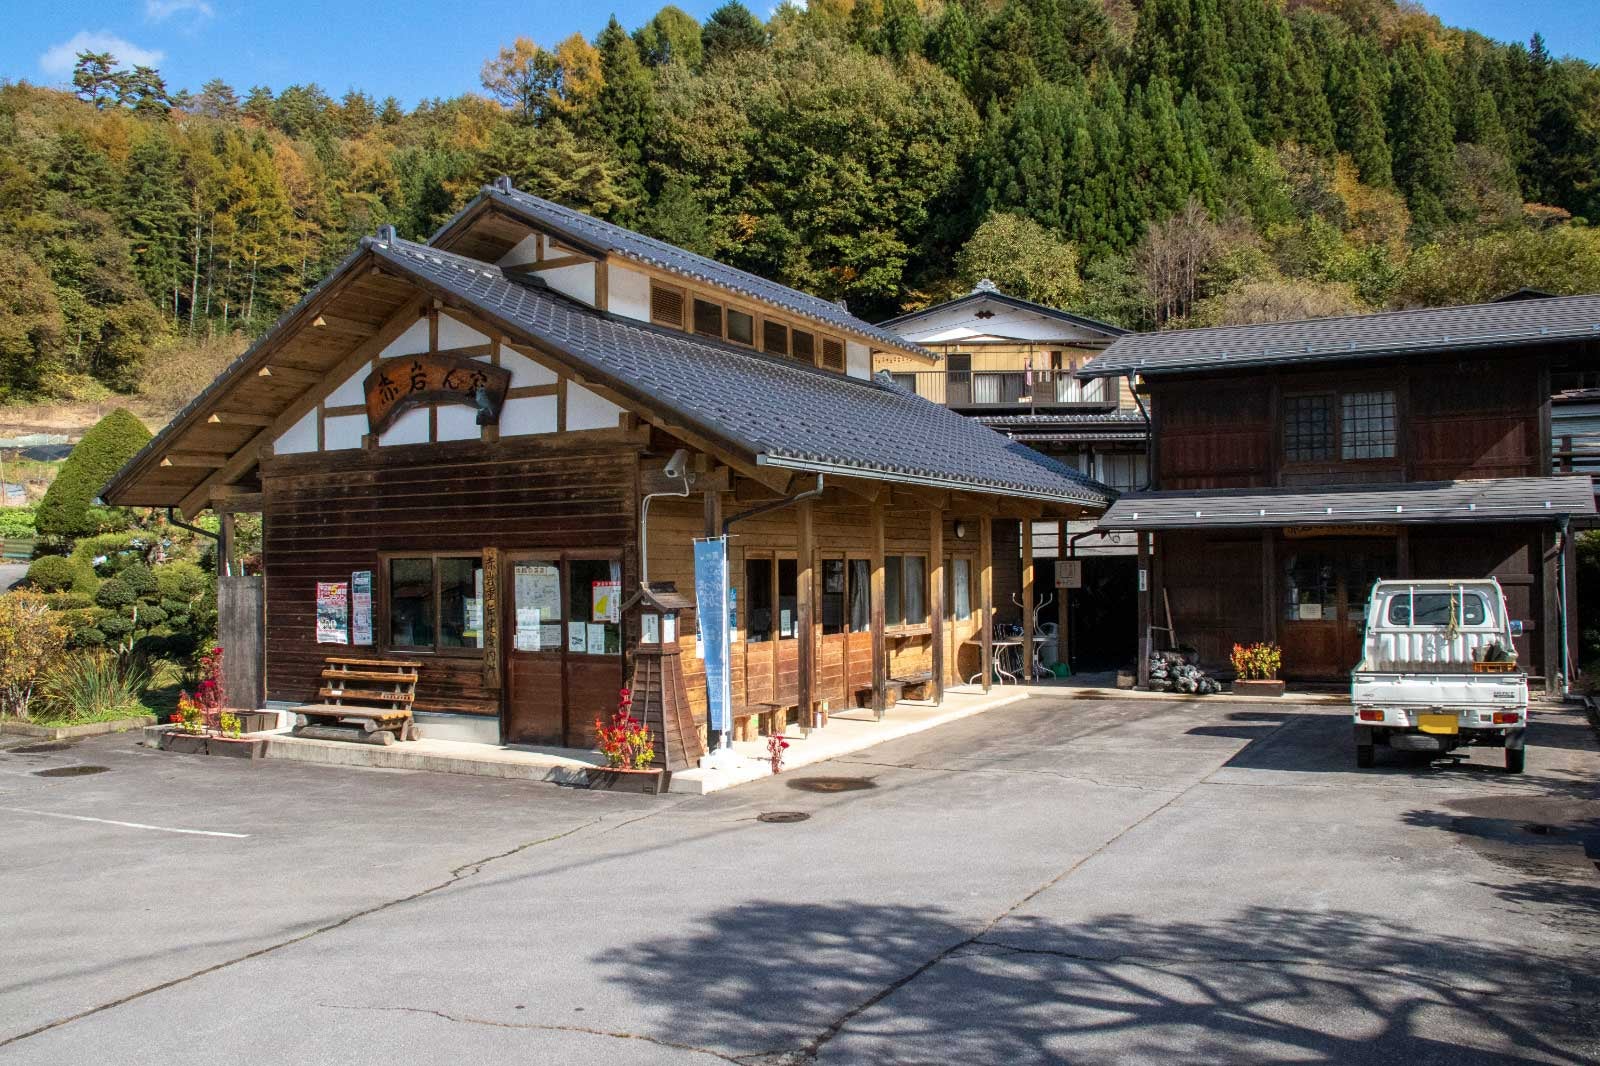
[[501, 552, 624, 747]]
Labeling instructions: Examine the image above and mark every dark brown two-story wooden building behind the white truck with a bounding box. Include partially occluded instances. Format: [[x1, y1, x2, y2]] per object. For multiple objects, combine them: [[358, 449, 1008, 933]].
[[1083, 296, 1600, 687]]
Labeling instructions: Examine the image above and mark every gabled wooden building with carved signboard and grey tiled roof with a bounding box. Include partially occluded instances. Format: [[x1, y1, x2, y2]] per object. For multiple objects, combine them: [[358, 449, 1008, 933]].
[[106, 182, 1110, 747]]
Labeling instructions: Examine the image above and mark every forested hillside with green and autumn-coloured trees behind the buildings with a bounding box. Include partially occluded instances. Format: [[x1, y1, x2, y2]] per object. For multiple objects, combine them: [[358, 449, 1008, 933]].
[[0, 0, 1600, 410]]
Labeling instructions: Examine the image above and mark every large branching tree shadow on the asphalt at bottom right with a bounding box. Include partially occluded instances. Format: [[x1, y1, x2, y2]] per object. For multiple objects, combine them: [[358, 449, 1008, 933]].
[[597, 900, 1600, 1066]]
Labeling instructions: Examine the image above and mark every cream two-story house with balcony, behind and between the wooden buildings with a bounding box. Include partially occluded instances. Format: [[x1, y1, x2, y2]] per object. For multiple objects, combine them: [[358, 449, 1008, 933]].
[[874, 279, 1149, 671]]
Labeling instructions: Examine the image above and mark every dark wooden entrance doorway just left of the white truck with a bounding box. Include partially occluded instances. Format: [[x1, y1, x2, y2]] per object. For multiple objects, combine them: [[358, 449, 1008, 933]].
[[1280, 539, 1395, 680]]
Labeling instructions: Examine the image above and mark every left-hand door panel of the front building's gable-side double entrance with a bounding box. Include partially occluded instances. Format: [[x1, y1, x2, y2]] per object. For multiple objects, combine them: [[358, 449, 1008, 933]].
[[501, 552, 566, 744]]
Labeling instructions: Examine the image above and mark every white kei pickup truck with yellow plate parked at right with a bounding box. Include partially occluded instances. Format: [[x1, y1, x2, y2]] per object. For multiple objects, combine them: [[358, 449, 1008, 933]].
[[1350, 578, 1528, 773]]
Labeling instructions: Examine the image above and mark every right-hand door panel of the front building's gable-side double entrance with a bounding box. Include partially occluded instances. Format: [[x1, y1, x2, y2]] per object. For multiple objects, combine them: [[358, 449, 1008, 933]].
[[562, 554, 624, 747]]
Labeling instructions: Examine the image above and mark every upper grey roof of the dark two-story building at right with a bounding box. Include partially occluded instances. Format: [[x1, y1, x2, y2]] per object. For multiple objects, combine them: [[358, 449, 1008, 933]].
[[1077, 293, 1600, 378]]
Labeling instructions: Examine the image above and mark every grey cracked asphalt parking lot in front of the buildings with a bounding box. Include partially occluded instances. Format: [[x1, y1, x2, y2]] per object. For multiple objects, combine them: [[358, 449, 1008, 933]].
[[0, 698, 1600, 1066]]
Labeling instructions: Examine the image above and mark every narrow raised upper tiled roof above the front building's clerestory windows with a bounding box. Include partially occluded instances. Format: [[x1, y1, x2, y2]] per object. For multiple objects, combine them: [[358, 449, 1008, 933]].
[[464, 184, 936, 359]]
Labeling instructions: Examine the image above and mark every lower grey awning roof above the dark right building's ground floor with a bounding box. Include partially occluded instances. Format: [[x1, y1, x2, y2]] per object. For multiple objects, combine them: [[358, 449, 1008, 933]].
[[1094, 475, 1595, 530]]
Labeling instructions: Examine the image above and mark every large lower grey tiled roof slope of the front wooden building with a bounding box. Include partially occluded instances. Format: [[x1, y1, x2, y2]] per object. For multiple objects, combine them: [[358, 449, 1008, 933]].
[[365, 238, 1115, 507]]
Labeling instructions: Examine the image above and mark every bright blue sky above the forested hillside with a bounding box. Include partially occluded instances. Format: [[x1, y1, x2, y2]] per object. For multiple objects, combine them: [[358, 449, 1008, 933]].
[[0, 0, 1600, 106]]
